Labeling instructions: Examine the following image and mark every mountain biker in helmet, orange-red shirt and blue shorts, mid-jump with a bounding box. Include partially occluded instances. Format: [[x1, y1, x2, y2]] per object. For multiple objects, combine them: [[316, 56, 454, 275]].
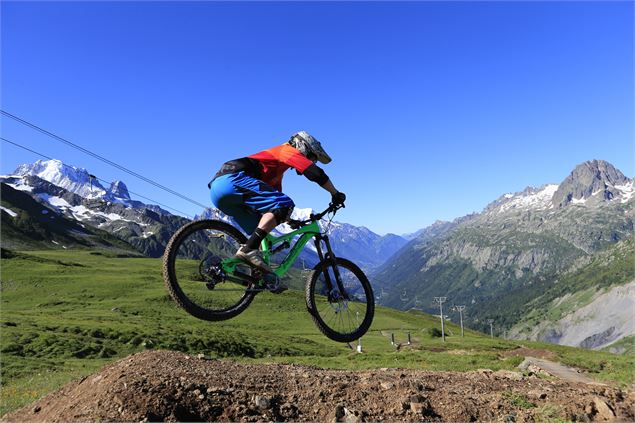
[[208, 131, 346, 288]]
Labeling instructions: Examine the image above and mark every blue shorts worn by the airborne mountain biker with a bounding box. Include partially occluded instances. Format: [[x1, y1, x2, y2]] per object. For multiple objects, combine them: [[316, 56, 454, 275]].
[[210, 172, 295, 234]]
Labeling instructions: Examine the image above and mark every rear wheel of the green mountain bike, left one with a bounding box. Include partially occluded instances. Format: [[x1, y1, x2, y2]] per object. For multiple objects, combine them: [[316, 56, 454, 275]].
[[163, 220, 257, 321]]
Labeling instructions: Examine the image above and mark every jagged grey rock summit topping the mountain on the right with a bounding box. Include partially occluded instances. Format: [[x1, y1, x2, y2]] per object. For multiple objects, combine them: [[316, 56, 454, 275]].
[[552, 160, 630, 207]]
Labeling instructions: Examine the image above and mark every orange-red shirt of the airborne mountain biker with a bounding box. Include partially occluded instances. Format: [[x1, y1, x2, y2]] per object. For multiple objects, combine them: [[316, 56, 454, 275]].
[[249, 144, 313, 191]]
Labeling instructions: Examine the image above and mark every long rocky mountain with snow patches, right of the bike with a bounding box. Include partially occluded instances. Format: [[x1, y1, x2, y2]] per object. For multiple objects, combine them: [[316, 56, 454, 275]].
[[374, 160, 635, 352]]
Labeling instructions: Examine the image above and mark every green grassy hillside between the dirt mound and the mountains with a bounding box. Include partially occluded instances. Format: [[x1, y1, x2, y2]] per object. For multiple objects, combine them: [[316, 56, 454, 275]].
[[0, 250, 633, 414]]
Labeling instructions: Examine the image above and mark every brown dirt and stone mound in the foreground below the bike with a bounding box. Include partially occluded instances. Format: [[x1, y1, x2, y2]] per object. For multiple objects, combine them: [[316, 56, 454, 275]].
[[1, 351, 635, 422]]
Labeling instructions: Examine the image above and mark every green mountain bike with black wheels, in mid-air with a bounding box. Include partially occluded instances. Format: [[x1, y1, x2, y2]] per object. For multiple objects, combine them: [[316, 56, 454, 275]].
[[163, 204, 375, 342]]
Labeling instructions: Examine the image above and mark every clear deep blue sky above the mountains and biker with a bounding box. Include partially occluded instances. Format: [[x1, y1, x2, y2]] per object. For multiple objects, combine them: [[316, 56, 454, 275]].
[[1, 1, 634, 233]]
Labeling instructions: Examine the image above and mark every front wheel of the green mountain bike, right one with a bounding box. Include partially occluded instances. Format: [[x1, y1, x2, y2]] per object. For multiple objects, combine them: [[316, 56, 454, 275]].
[[306, 258, 375, 342]]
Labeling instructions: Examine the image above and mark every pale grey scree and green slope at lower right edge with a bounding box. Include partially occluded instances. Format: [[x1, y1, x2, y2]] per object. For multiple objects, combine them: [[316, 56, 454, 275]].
[[506, 236, 635, 353]]
